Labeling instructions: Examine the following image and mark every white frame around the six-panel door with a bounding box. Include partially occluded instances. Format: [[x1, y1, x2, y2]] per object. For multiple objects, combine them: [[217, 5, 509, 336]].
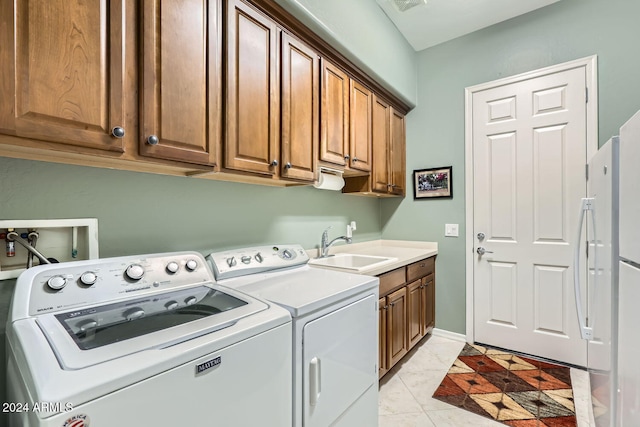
[[464, 55, 598, 343]]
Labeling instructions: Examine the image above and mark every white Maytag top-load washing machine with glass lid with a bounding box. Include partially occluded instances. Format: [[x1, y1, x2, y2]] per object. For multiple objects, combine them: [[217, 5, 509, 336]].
[[7, 252, 292, 427]]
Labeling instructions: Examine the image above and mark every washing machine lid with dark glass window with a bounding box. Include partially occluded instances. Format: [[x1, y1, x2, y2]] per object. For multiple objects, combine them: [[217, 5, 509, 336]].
[[36, 285, 268, 369]]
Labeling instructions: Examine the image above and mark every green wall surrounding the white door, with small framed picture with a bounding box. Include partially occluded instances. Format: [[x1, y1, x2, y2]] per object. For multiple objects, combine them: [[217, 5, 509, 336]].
[[382, 0, 640, 333]]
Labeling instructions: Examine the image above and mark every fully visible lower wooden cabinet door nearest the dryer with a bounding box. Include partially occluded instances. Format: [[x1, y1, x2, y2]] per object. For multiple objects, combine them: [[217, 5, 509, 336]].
[[387, 286, 408, 366]]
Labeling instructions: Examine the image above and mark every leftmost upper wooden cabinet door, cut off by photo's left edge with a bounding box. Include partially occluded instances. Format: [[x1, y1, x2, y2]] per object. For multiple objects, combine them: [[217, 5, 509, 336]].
[[0, 0, 126, 152]]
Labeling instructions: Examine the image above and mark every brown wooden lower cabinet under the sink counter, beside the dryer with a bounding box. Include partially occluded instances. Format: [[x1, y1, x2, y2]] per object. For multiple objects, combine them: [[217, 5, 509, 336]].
[[378, 257, 435, 378]]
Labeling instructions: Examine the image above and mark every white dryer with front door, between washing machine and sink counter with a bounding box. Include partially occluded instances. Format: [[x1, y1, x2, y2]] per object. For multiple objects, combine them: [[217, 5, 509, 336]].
[[207, 245, 379, 427]]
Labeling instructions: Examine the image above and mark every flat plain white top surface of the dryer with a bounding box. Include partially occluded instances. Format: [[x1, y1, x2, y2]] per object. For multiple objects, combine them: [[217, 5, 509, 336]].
[[220, 266, 380, 317]]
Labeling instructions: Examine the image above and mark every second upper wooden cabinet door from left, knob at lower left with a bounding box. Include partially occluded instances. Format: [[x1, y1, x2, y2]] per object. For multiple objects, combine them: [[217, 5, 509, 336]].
[[139, 0, 221, 165]]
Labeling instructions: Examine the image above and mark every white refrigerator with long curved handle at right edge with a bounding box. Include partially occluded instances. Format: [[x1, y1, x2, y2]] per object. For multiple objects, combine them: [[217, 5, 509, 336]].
[[574, 112, 640, 427]]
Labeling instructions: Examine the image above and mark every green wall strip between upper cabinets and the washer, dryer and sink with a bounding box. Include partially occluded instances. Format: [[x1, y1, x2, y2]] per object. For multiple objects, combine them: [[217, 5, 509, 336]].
[[0, 158, 381, 257]]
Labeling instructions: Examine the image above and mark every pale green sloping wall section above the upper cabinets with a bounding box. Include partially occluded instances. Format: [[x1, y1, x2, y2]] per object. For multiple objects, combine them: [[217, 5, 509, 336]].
[[275, 0, 417, 106]]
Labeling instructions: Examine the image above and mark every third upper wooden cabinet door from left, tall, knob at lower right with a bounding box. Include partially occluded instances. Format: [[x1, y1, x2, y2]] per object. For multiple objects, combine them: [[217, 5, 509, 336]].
[[224, 0, 280, 175]]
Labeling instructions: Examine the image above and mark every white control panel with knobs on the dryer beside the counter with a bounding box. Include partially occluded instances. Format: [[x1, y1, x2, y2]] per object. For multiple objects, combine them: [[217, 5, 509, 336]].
[[207, 245, 309, 280]]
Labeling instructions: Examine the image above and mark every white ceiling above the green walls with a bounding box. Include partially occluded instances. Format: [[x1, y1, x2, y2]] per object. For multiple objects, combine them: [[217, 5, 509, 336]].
[[376, 0, 560, 51]]
